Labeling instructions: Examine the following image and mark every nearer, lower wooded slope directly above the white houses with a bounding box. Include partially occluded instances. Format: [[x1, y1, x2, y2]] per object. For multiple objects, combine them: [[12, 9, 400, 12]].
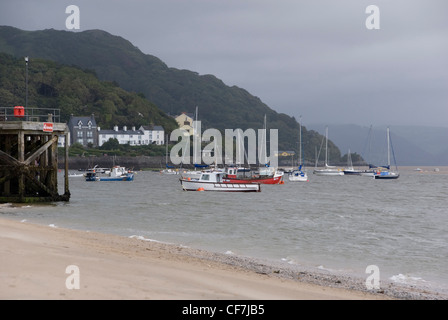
[[0, 53, 177, 130]]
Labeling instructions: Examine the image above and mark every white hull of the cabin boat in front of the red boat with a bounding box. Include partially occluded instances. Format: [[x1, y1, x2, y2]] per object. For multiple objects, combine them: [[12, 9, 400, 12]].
[[179, 179, 261, 192]]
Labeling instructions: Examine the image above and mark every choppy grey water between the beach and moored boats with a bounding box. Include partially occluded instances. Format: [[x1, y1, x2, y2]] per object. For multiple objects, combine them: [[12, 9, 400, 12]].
[[0, 169, 448, 292]]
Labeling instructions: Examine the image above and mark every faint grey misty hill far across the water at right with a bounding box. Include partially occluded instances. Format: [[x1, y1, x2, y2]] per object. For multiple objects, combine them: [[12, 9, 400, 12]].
[[308, 124, 448, 166]]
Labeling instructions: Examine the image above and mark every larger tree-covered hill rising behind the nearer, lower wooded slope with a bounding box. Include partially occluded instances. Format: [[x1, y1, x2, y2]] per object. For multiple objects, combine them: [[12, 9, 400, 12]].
[[0, 26, 341, 159]]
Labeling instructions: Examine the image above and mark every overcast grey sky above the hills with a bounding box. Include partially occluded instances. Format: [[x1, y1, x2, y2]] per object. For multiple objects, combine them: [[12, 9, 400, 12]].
[[0, 0, 448, 127]]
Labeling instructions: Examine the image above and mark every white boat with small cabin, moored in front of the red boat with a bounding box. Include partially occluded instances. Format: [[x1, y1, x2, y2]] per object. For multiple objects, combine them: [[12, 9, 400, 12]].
[[179, 171, 261, 192]]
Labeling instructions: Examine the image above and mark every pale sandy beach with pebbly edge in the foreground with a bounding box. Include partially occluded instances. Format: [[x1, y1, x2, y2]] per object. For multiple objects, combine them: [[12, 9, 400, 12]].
[[0, 218, 440, 300]]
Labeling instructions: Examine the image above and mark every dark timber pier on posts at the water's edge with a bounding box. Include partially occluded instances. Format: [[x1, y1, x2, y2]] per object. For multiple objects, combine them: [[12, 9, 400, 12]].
[[0, 117, 70, 203]]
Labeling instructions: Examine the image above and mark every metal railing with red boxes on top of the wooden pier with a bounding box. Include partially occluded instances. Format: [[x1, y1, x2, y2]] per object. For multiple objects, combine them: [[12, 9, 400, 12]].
[[0, 106, 61, 122]]
